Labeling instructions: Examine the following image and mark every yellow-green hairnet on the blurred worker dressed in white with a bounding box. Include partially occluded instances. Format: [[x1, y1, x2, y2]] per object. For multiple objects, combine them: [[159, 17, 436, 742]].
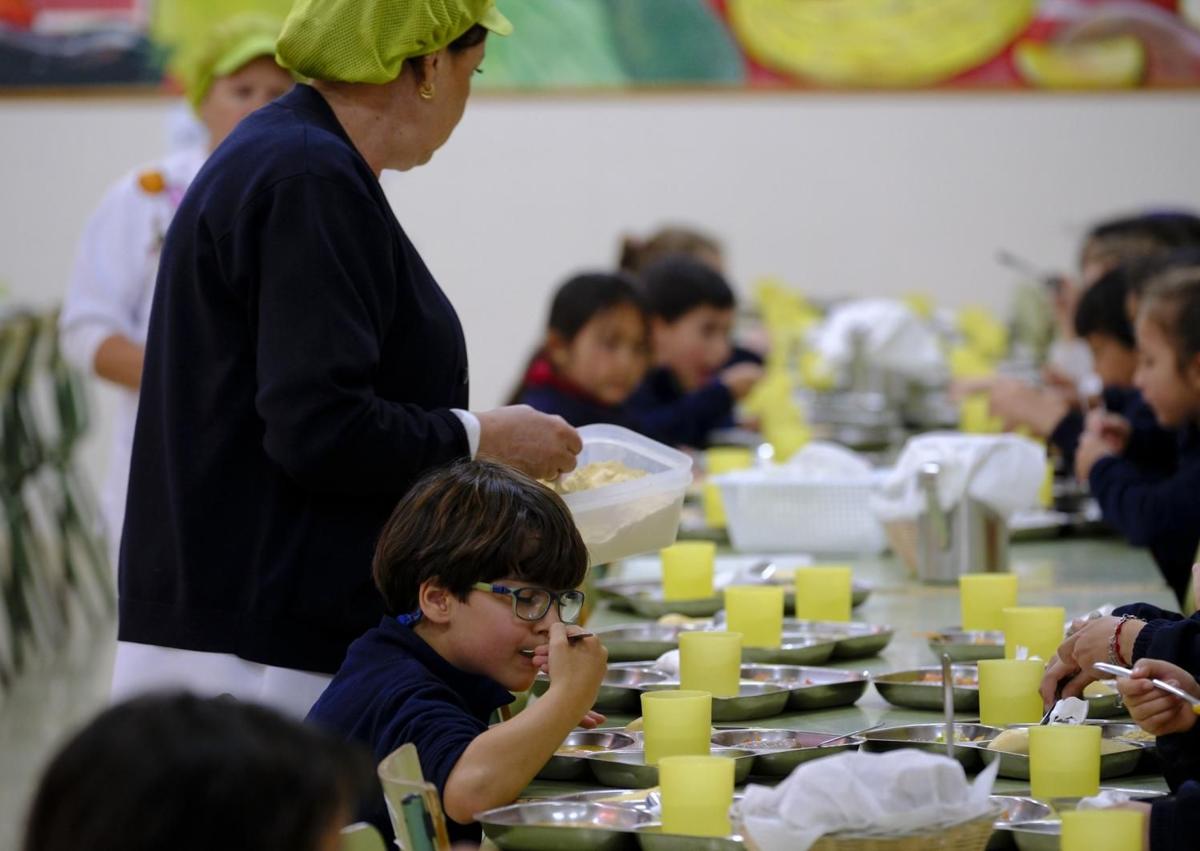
[[172, 14, 280, 109]]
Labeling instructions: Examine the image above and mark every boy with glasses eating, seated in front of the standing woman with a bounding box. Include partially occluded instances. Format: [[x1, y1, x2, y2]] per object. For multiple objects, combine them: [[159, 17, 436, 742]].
[[308, 461, 607, 841]]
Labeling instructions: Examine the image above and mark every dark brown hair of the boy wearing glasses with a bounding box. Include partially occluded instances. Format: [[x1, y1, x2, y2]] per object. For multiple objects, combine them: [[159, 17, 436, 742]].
[[372, 461, 588, 615]]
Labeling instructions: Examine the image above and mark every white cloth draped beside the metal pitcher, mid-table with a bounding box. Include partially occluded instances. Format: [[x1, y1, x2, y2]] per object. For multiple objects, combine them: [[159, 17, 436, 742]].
[[871, 432, 1045, 522]]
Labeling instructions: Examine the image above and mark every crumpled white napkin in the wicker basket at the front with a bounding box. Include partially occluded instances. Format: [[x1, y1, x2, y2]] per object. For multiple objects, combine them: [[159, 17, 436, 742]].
[[740, 749, 1000, 851]]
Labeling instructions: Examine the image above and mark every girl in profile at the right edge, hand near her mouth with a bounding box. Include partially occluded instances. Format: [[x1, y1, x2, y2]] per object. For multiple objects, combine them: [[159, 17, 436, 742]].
[[1075, 265, 1200, 600]]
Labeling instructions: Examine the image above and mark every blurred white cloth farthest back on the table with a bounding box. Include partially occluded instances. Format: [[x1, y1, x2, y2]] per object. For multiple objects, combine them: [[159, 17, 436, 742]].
[[811, 299, 946, 380]]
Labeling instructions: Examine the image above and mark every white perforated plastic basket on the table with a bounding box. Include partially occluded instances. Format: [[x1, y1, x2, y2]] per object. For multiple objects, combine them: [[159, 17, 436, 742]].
[[713, 468, 887, 553]]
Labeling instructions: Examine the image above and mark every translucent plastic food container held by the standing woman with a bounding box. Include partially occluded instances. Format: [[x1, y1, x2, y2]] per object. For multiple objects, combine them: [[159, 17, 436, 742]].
[[563, 425, 691, 564]]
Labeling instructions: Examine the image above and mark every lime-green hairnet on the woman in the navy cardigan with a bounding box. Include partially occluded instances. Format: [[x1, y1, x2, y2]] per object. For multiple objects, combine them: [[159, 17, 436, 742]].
[[276, 0, 512, 84]]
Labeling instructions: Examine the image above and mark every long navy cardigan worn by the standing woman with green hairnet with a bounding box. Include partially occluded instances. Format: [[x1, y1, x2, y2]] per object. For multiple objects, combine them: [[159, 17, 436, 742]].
[[119, 85, 469, 673]]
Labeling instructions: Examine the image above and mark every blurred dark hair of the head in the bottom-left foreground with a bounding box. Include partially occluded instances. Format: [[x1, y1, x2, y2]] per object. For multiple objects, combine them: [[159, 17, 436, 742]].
[[23, 694, 374, 851]]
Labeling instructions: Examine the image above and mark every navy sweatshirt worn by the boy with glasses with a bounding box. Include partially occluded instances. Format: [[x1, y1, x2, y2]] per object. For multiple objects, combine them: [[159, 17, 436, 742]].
[[308, 617, 512, 846]]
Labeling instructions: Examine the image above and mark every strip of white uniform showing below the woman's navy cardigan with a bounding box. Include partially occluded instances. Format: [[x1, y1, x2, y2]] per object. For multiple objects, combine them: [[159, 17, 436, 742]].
[[110, 641, 334, 719]]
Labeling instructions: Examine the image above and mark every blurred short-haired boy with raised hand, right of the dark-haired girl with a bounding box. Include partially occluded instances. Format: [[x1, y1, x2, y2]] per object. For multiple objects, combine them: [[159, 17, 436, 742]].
[[629, 256, 762, 449]]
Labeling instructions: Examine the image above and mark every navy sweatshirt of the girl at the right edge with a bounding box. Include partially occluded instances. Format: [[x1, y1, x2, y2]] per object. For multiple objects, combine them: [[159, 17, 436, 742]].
[[1088, 425, 1200, 601]]
